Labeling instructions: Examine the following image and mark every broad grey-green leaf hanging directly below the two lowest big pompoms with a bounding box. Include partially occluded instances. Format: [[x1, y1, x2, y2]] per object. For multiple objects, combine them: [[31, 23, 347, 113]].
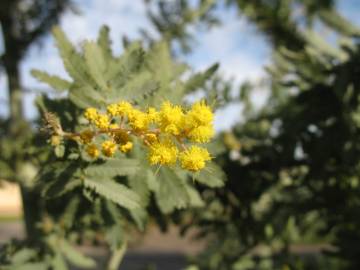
[[155, 167, 189, 214]]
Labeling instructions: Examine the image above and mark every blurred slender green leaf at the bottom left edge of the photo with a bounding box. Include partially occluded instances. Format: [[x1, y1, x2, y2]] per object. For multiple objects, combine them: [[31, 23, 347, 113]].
[[60, 240, 96, 268]]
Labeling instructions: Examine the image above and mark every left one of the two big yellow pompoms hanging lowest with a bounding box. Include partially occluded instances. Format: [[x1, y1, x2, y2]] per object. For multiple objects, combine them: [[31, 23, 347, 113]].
[[149, 140, 178, 165]]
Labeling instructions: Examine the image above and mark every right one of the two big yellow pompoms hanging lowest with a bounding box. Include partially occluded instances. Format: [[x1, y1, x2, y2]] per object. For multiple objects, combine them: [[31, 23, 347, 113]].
[[179, 146, 211, 172]]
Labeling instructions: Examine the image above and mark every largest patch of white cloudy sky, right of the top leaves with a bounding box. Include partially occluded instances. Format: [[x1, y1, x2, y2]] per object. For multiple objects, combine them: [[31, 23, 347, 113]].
[[187, 11, 268, 82]]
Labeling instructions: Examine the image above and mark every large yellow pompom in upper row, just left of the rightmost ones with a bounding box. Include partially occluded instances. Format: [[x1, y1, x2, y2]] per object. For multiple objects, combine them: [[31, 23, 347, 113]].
[[157, 101, 184, 136]]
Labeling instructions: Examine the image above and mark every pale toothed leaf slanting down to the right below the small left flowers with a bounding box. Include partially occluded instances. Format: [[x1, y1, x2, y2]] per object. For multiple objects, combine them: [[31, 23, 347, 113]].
[[84, 177, 141, 209]]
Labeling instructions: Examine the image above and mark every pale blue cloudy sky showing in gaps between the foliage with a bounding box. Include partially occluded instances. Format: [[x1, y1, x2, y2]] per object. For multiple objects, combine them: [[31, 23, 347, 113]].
[[0, 0, 360, 130]]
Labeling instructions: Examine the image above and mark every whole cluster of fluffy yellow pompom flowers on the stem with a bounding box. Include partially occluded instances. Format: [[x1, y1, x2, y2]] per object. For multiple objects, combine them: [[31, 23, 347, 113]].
[[79, 101, 214, 172]]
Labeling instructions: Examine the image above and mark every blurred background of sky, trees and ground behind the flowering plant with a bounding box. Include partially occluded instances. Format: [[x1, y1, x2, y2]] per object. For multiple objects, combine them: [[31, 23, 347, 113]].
[[0, 0, 360, 269]]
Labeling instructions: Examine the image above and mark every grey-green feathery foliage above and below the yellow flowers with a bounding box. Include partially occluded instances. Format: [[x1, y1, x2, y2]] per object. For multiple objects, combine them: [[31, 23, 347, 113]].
[[0, 27, 225, 269]]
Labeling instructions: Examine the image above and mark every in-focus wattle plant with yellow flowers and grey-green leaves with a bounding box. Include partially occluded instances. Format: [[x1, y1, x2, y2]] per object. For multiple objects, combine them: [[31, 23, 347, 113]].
[[0, 27, 225, 270]]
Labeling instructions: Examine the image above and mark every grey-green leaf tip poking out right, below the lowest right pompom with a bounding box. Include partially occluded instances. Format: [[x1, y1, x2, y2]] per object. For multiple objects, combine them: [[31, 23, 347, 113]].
[[194, 162, 226, 188]]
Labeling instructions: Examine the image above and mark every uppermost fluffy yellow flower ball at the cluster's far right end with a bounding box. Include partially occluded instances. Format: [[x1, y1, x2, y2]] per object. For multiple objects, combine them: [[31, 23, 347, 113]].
[[186, 100, 214, 127]]
